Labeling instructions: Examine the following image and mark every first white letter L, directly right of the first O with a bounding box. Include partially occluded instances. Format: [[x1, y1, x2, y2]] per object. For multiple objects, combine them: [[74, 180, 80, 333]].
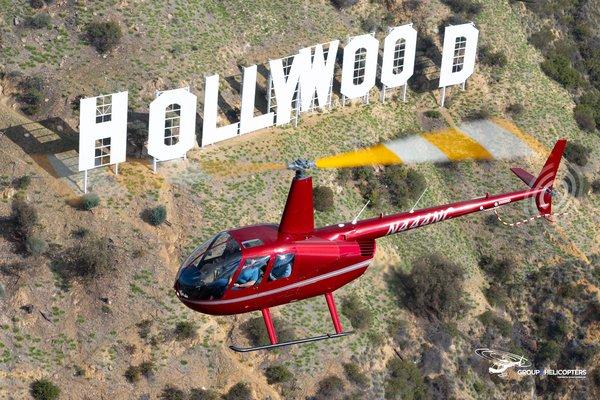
[[200, 75, 240, 147]]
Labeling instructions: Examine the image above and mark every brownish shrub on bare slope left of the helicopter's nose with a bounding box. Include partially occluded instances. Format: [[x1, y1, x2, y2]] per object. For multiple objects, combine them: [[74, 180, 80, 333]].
[[59, 236, 114, 279]]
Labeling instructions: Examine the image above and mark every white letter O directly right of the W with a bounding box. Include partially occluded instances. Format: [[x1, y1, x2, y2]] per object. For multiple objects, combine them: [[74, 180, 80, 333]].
[[340, 34, 379, 99]]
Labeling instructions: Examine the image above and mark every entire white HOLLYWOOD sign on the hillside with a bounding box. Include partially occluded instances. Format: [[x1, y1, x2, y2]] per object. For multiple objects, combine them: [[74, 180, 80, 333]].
[[79, 23, 479, 191]]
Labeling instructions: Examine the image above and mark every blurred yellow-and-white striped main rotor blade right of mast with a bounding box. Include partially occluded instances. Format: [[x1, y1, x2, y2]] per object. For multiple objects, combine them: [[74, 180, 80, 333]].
[[315, 119, 533, 168]]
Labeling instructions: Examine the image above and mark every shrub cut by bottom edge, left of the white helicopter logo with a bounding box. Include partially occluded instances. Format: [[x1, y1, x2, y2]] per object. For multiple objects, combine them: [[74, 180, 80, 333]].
[[385, 358, 427, 400]]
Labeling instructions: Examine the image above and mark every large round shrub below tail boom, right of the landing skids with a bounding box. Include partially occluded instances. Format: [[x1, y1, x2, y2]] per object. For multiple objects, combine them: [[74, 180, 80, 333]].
[[390, 255, 466, 319]]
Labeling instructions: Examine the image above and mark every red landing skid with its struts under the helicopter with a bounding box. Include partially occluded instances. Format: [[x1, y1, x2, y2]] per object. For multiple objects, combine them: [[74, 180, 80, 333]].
[[229, 293, 354, 353]]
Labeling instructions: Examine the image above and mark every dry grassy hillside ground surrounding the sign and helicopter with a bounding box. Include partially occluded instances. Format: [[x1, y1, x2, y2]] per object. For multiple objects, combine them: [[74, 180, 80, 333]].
[[0, 0, 600, 399]]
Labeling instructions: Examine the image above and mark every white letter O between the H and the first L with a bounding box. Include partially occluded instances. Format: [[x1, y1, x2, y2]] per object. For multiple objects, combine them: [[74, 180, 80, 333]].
[[148, 89, 197, 161]]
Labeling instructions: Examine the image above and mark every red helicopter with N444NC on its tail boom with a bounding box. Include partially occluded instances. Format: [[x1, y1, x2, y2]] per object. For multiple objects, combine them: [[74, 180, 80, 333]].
[[174, 139, 566, 352]]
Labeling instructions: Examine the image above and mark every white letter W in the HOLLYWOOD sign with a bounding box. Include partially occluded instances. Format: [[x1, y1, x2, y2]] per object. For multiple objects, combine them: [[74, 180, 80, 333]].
[[300, 40, 340, 112]]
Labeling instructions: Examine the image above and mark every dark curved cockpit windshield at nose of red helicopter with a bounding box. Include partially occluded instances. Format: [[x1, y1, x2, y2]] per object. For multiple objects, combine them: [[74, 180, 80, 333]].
[[177, 232, 242, 300]]
